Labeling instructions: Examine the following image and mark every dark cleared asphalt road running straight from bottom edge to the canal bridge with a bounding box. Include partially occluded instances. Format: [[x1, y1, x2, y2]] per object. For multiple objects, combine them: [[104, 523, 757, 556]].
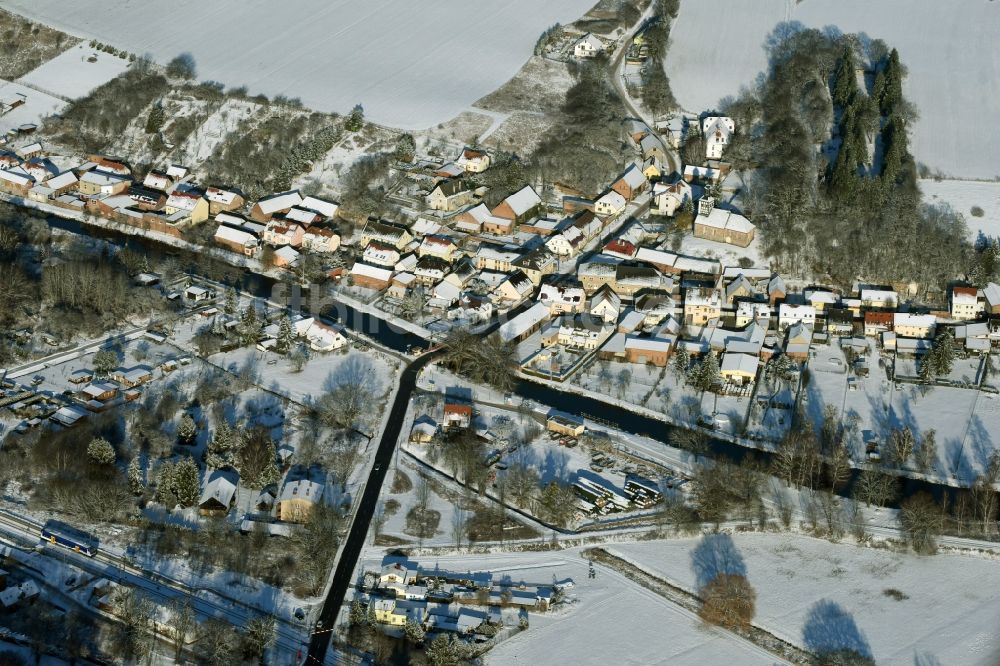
[[306, 350, 440, 664]]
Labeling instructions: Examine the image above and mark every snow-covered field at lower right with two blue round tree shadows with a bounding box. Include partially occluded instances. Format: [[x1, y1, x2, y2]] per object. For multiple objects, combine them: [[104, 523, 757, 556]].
[[609, 534, 1000, 665]]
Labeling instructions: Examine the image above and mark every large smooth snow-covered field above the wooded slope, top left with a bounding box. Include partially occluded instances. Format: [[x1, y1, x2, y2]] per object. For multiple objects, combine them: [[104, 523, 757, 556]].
[[0, 0, 593, 129]]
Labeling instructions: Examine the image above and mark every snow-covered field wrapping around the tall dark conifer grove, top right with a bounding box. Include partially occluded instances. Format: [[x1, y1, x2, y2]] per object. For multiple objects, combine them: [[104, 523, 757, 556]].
[[664, 0, 1000, 178]]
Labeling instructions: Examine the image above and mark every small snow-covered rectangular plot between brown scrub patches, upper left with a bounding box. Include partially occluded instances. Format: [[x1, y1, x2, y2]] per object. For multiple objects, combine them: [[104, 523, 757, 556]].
[[20, 43, 128, 99]]
